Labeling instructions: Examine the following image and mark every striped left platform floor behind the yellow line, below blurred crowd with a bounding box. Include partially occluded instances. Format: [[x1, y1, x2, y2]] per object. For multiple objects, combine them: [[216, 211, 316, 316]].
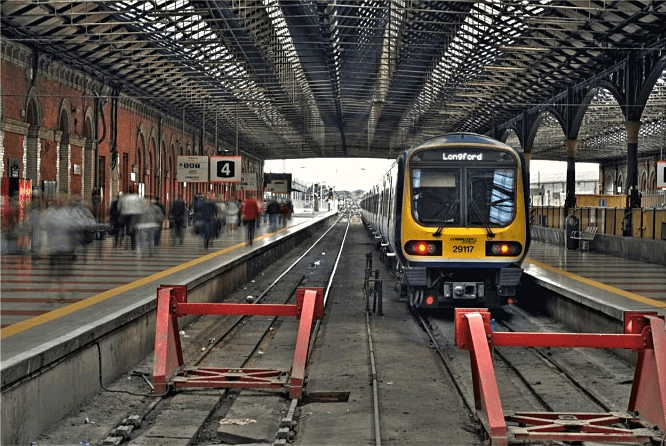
[[0, 213, 316, 328]]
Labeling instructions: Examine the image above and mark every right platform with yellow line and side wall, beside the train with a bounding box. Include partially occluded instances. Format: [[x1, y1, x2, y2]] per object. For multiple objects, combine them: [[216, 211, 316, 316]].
[[522, 241, 666, 340]]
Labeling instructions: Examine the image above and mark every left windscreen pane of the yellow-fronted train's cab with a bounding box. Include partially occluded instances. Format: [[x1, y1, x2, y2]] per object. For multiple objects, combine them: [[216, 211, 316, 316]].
[[411, 168, 461, 226]]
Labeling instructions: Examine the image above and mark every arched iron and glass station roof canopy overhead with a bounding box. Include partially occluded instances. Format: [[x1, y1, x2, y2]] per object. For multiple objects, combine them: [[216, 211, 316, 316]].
[[0, 0, 666, 162]]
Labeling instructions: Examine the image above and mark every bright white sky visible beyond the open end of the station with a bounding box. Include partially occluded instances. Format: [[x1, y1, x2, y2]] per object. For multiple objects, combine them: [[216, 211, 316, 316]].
[[265, 158, 599, 191]]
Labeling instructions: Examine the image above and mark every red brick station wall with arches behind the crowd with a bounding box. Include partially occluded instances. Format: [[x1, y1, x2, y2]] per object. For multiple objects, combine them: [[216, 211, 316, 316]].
[[0, 39, 261, 217]]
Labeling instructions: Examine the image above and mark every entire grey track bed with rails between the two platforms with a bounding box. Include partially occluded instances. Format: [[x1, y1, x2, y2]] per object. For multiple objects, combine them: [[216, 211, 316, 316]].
[[37, 218, 660, 446]]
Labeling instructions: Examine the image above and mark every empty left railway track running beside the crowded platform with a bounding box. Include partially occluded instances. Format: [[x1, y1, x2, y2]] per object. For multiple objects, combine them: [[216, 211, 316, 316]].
[[35, 214, 348, 445]]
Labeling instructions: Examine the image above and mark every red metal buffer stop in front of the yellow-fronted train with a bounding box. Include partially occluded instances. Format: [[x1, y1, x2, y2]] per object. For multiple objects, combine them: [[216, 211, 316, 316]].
[[455, 308, 666, 445]]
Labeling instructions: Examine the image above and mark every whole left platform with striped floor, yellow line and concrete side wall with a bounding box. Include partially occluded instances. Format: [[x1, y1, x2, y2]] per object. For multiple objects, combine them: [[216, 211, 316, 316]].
[[0, 212, 338, 444]]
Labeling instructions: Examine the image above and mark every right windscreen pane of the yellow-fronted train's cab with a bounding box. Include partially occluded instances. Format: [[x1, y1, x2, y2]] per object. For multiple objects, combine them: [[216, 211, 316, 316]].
[[466, 168, 516, 227]]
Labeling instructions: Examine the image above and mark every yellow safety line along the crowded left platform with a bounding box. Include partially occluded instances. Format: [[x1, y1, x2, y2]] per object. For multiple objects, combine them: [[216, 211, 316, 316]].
[[0, 228, 286, 339]]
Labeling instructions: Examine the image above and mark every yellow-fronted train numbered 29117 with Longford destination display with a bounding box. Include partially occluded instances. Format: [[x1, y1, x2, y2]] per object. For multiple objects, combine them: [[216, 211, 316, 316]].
[[359, 133, 530, 309]]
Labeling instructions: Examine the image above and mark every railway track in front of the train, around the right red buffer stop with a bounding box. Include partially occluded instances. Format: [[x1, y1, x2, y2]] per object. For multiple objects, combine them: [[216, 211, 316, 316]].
[[415, 307, 663, 444]]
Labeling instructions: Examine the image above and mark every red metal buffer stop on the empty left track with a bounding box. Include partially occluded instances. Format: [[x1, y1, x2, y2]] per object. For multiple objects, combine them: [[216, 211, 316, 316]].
[[153, 285, 324, 398]]
